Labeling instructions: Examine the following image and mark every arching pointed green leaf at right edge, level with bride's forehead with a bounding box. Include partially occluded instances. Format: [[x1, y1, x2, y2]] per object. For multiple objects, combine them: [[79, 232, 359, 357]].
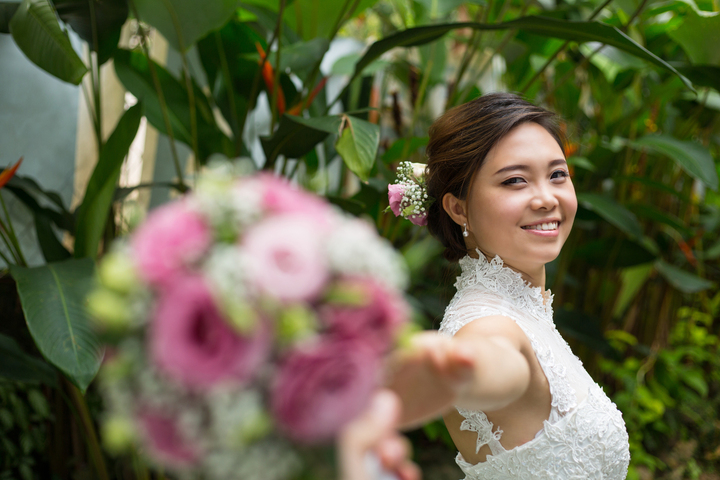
[[629, 135, 718, 191]]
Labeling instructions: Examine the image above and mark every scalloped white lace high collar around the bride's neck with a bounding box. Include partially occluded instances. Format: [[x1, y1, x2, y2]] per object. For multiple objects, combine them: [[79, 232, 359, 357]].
[[455, 249, 553, 323]]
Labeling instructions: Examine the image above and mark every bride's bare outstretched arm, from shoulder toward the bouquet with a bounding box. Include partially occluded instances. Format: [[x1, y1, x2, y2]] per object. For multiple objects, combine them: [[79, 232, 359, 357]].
[[387, 316, 532, 428]]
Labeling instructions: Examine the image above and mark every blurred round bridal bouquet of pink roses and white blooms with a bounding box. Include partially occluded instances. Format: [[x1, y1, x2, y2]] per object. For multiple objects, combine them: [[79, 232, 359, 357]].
[[88, 169, 409, 480]]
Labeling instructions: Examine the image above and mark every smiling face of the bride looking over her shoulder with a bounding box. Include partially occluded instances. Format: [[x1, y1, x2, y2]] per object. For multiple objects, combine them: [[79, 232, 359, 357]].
[[466, 122, 577, 272]]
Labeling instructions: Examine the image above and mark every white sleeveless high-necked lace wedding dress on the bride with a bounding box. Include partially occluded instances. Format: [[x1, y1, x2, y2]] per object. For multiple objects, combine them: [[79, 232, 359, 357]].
[[440, 252, 630, 480]]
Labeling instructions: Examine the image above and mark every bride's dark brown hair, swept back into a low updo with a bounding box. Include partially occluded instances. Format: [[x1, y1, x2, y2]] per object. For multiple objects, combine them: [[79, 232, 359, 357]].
[[426, 93, 565, 261]]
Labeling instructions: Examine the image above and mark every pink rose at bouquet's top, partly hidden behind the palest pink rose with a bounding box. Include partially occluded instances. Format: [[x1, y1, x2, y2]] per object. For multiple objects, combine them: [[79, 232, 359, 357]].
[[239, 173, 334, 223]]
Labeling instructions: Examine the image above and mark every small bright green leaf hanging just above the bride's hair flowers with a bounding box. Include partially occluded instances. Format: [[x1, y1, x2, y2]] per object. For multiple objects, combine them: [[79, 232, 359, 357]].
[[335, 116, 380, 182]]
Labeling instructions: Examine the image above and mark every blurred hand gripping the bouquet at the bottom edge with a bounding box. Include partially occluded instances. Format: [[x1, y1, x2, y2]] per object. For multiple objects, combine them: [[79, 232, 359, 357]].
[[338, 390, 420, 480]]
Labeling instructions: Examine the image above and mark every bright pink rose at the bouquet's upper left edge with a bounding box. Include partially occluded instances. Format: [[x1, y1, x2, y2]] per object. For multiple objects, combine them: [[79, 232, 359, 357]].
[[131, 201, 212, 287]]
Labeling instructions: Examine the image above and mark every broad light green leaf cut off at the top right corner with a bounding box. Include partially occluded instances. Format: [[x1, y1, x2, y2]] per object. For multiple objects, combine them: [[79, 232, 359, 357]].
[[668, 9, 720, 66]]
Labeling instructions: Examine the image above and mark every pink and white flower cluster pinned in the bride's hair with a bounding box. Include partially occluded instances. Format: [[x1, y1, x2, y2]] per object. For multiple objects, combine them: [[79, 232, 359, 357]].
[[388, 162, 435, 226]]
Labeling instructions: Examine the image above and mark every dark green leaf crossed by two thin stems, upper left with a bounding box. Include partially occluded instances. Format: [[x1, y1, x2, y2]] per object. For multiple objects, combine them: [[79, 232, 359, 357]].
[[113, 49, 232, 162]]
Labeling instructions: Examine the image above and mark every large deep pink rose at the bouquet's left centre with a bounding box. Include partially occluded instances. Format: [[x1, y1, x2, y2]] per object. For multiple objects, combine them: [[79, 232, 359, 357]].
[[149, 277, 270, 388]]
